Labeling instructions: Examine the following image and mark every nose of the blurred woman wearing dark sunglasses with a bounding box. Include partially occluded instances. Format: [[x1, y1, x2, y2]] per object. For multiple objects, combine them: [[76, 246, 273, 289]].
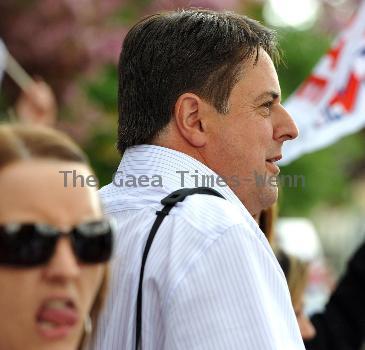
[[44, 238, 80, 282]]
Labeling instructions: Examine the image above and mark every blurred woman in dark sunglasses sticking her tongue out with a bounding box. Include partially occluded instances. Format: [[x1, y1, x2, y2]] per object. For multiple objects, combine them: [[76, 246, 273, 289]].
[[0, 125, 112, 350]]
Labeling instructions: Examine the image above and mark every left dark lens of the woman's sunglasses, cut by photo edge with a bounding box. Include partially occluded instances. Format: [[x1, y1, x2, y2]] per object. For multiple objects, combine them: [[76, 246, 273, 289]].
[[0, 224, 57, 268]]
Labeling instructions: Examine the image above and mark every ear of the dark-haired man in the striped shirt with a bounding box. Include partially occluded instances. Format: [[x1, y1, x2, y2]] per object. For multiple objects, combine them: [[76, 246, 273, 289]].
[[174, 93, 207, 147]]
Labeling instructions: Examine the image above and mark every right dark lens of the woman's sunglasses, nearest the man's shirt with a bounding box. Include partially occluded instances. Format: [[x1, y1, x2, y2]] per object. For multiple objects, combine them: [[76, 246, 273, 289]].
[[73, 220, 113, 264]]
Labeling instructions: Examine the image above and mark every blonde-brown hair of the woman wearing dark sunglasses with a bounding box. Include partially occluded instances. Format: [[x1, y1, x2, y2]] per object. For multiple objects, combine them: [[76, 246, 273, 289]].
[[0, 124, 109, 349]]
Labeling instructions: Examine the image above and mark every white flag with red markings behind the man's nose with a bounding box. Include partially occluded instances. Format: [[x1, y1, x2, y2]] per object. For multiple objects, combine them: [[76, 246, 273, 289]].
[[280, 1, 365, 165]]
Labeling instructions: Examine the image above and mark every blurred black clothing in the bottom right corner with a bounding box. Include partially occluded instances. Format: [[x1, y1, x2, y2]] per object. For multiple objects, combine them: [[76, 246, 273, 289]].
[[305, 242, 365, 350]]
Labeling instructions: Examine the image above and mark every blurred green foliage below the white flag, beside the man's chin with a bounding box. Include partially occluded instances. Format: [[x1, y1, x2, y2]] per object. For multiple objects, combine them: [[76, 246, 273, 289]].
[[280, 133, 365, 216]]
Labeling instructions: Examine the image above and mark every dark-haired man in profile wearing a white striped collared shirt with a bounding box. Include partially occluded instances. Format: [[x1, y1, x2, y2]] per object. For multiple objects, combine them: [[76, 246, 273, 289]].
[[92, 9, 304, 350]]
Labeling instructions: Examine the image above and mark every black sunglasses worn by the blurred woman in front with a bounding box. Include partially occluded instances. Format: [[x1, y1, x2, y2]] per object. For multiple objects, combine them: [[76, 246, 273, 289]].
[[0, 219, 113, 268]]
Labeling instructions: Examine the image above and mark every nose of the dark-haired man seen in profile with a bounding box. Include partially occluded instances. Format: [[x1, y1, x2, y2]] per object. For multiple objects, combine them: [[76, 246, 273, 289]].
[[273, 105, 299, 143]]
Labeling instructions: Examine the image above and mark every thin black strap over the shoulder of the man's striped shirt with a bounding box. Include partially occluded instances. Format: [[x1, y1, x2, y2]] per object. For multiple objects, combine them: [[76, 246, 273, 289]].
[[136, 187, 224, 350]]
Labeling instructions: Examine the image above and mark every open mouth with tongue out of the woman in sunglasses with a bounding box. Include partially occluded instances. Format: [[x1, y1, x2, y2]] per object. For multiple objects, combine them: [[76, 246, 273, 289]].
[[36, 298, 79, 339]]
